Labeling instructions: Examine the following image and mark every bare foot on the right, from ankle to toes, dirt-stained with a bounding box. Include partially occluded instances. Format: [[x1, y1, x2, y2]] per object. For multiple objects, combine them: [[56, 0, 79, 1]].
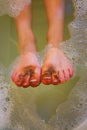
[[41, 48, 73, 85]]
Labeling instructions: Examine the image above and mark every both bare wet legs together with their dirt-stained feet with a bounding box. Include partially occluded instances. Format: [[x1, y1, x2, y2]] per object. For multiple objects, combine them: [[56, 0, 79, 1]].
[[12, 0, 73, 88]]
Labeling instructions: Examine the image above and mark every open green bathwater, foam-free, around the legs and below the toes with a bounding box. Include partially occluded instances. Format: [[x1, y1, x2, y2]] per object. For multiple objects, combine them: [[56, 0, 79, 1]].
[[0, 0, 79, 125]]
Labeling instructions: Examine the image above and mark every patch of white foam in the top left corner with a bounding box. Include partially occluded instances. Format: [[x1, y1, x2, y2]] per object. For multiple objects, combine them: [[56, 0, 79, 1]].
[[0, 0, 31, 17]]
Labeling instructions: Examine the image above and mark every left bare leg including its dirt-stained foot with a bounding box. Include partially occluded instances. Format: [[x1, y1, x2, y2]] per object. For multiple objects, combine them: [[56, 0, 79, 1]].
[[12, 4, 41, 87]]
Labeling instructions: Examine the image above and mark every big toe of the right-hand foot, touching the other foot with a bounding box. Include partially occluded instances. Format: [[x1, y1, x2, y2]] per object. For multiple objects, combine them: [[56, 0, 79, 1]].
[[41, 71, 52, 85]]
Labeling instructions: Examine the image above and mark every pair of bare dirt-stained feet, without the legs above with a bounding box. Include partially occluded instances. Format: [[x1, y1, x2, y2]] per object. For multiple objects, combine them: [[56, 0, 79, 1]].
[[12, 48, 74, 88]]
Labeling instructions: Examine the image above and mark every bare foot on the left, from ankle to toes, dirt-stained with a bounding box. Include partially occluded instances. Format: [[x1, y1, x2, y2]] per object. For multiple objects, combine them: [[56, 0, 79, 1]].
[[12, 52, 41, 88]]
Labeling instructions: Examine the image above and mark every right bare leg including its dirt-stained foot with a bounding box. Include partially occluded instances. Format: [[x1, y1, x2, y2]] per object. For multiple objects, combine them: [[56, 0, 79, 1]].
[[42, 0, 73, 84]]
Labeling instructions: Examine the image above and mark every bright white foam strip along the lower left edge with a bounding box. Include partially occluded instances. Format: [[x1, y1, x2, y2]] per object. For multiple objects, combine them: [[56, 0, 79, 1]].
[[0, 66, 11, 130]]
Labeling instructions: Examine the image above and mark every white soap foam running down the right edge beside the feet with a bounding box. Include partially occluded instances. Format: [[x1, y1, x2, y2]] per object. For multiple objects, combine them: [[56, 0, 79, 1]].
[[49, 0, 87, 130]]
